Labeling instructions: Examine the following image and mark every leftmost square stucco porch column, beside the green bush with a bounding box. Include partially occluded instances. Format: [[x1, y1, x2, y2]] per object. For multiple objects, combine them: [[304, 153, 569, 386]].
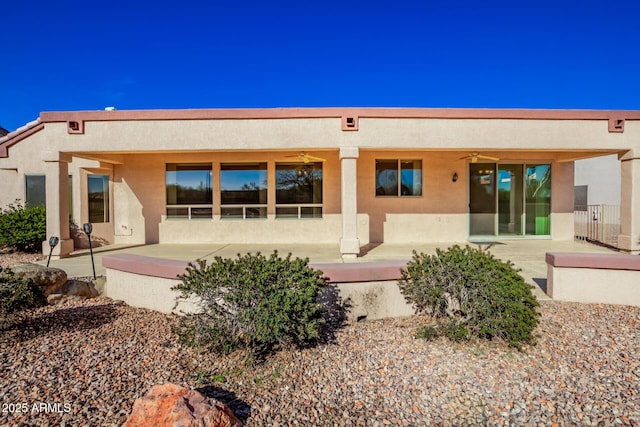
[[42, 153, 73, 258]]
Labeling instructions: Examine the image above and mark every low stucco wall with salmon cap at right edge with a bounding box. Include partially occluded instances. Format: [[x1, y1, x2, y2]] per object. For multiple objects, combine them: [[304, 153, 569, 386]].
[[546, 253, 640, 307]]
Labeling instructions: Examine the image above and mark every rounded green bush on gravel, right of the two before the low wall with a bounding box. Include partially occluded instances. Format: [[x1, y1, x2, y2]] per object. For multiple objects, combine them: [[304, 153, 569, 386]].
[[398, 245, 539, 348]]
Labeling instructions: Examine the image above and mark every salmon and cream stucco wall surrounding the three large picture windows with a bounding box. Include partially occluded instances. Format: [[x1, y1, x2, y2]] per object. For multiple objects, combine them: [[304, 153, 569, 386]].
[[114, 150, 344, 243]]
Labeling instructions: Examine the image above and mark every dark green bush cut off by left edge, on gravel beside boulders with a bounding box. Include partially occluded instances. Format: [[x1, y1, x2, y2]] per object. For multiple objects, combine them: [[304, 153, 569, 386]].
[[0, 268, 47, 321]]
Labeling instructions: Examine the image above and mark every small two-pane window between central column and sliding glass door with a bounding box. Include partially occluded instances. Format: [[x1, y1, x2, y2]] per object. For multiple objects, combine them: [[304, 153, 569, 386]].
[[376, 159, 422, 197]]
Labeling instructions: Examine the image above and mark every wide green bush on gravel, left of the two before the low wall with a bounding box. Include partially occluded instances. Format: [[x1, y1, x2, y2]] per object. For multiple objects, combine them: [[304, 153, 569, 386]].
[[173, 252, 327, 355]]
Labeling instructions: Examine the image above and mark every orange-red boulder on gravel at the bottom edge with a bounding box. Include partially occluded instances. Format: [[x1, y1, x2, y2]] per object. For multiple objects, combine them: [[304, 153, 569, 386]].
[[123, 383, 242, 427]]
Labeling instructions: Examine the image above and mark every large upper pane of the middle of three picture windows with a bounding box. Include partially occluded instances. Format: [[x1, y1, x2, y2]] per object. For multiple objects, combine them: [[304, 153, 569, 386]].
[[220, 163, 267, 205]]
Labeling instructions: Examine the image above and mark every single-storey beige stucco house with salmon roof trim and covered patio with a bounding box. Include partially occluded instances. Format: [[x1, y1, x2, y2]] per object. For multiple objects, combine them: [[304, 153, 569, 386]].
[[0, 108, 640, 258]]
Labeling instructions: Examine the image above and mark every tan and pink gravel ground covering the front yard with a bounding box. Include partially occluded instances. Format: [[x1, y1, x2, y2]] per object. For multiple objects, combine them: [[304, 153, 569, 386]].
[[0, 298, 640, 426]]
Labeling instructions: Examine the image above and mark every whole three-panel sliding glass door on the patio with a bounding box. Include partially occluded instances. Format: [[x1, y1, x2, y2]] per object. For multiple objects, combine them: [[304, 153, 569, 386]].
[[469, 163, 551, 237]]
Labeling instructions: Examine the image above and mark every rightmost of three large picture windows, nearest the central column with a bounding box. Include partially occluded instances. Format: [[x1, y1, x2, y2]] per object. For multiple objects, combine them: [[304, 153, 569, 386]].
[[276, 162, 322, 218]]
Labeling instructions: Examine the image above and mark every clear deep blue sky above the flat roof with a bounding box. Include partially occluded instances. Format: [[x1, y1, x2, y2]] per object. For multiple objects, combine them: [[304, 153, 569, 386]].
[[0, 0, 640, 130]]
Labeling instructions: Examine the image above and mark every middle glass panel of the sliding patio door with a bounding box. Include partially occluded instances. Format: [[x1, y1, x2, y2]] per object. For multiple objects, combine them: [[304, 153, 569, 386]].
[[498, 165, 523, 236]]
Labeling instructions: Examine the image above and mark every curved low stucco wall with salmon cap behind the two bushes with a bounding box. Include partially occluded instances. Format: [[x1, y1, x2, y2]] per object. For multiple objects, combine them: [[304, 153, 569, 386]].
[[102, 254, 414, 321]]
